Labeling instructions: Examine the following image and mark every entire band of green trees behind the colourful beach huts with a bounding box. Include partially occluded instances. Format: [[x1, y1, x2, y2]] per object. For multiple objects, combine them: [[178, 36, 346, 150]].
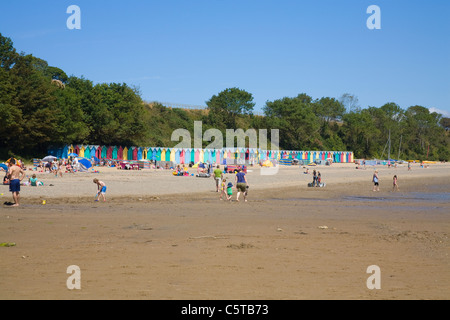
[[0, 34, 450, 161]]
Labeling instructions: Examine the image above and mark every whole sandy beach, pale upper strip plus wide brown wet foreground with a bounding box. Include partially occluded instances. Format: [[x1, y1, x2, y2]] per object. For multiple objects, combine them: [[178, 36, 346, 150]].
[[0, 164, 450, 300]]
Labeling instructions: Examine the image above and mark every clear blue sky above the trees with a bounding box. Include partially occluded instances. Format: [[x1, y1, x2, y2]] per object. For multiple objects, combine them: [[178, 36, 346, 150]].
[[0, 0, 450, 116]]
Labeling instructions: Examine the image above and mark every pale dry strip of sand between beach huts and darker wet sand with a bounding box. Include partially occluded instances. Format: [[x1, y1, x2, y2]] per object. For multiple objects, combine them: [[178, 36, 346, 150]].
[[0, 164, 450, 204]]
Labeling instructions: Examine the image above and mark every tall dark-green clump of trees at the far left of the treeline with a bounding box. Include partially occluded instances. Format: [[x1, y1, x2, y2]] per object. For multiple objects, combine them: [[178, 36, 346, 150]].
[[0, 34, 148, 158]]
